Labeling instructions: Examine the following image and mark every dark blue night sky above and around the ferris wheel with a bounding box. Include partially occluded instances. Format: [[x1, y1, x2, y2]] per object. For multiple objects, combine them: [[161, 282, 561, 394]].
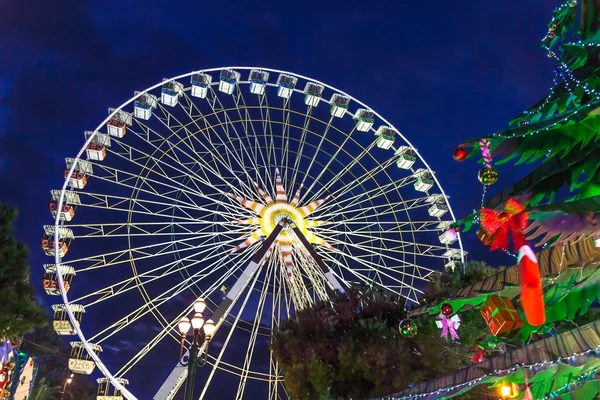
[[0, 0, 558, 399]]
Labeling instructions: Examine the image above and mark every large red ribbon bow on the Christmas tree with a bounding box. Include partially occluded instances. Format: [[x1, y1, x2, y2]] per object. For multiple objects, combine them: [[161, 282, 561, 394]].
[[480, 199, 528, 251]]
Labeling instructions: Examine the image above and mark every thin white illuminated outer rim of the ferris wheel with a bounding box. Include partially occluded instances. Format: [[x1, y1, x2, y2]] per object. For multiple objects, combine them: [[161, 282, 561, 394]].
[[54, 66, 464, 399]]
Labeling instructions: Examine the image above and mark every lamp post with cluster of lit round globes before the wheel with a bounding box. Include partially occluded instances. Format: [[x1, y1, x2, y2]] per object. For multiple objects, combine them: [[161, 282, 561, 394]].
[[179, 299, 215, 400]]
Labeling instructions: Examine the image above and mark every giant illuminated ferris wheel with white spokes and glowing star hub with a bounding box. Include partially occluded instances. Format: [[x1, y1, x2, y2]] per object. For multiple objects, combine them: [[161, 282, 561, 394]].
[[42, 67, 464, 400]]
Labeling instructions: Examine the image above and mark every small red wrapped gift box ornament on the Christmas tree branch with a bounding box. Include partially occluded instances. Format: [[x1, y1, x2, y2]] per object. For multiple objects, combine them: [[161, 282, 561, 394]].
[[481, 296, 524, 338]]
